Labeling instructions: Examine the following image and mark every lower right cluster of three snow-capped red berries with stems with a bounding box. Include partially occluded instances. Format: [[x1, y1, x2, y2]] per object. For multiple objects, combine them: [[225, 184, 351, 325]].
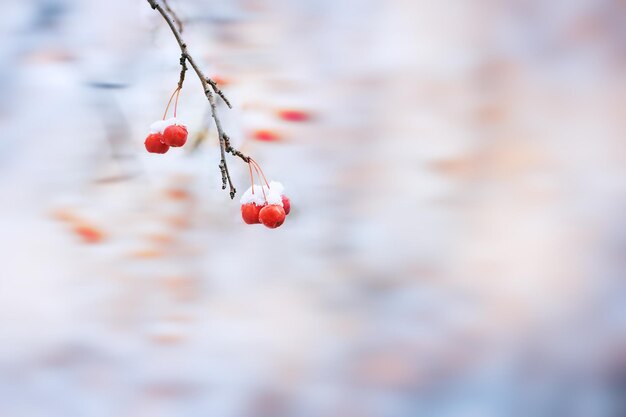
[[240, 158, 291, 229]]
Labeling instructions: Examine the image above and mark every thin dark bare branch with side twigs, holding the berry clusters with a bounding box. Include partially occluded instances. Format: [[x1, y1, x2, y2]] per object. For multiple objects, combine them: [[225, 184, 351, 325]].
[[147, 0, 244, 198]]
